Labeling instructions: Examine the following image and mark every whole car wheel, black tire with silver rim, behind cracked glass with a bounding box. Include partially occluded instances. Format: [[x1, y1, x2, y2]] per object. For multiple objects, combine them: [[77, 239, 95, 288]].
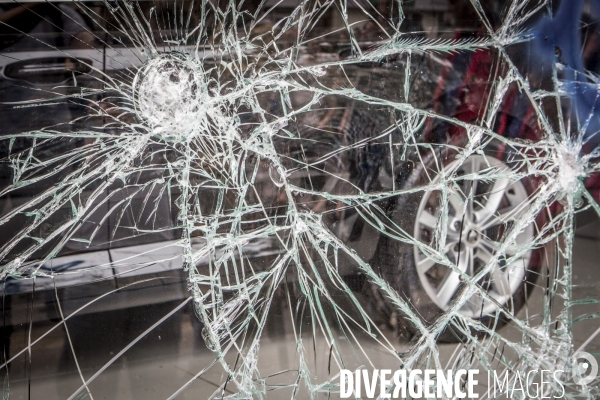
[[367, 144, 542, 342]]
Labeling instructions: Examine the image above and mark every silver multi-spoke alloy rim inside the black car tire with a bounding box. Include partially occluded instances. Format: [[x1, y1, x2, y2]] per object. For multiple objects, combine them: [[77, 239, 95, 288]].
[[414, 155, 534, 318]]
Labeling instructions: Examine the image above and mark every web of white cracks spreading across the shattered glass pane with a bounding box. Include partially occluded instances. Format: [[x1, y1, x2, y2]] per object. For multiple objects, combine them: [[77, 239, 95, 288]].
[[0, 0, 600, 398]]
